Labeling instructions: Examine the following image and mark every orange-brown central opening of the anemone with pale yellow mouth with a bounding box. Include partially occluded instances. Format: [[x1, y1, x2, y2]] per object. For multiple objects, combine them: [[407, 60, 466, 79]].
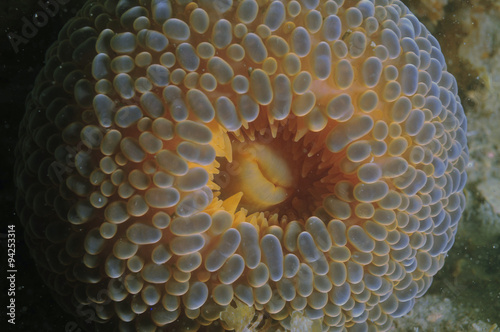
[[214, 121, 332, 220]]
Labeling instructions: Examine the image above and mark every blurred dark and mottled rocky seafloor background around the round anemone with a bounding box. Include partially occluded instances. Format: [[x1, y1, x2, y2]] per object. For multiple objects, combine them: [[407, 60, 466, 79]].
[[0, 0, 500, 332]]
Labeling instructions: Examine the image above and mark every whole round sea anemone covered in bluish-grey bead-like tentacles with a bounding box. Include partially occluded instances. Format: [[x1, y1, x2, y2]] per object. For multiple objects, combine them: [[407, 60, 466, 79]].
[[17, 0, 467, 331]]
